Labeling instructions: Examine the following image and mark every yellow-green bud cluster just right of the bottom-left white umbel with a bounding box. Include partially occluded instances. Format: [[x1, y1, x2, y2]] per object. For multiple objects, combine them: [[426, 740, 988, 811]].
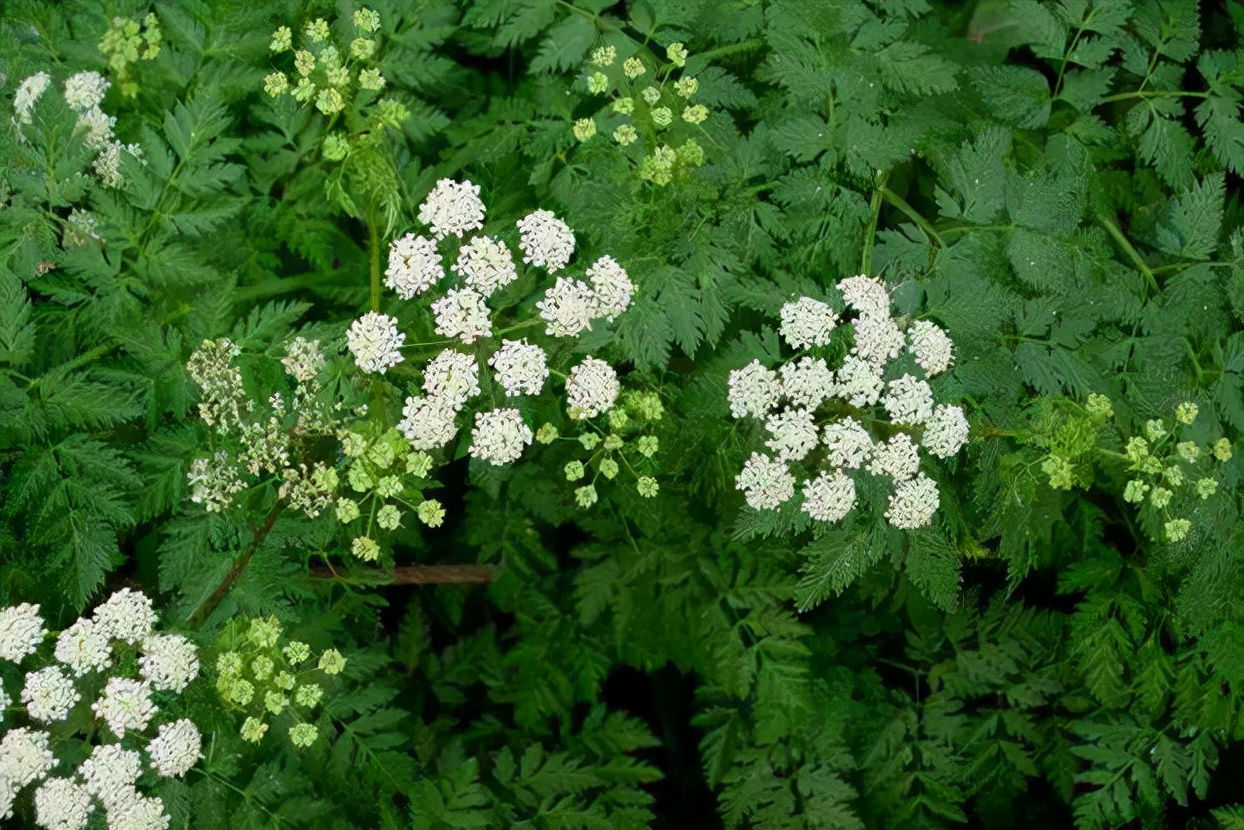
[[215, 617, 346, 747]]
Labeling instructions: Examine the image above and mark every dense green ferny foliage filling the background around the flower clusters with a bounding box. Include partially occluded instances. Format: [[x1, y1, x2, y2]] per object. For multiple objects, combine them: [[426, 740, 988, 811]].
[[0, 0, 1244, 830]]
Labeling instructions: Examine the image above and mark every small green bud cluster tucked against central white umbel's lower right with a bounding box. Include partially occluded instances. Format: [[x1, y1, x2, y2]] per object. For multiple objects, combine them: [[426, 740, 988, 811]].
[[535, 391, 664, 508]]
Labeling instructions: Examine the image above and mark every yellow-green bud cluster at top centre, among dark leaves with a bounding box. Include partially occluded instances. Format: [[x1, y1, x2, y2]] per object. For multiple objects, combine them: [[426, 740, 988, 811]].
[[572, 44, 709, 184]]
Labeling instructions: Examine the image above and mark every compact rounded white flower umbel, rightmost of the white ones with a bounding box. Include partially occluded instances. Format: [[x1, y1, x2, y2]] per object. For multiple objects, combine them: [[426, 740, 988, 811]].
[[728, 275, 968, 529]]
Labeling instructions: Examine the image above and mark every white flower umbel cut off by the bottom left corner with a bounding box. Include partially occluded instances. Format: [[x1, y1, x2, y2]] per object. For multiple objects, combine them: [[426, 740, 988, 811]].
[[0, 589, 203, 830]]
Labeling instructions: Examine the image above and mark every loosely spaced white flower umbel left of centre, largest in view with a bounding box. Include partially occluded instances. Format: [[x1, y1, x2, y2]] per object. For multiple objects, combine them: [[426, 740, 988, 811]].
[[346, 179, 634, 464]]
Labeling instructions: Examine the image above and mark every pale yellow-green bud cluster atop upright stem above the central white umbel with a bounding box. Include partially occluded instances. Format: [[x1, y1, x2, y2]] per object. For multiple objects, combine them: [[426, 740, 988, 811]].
[[264, 7, 411, 162]]
